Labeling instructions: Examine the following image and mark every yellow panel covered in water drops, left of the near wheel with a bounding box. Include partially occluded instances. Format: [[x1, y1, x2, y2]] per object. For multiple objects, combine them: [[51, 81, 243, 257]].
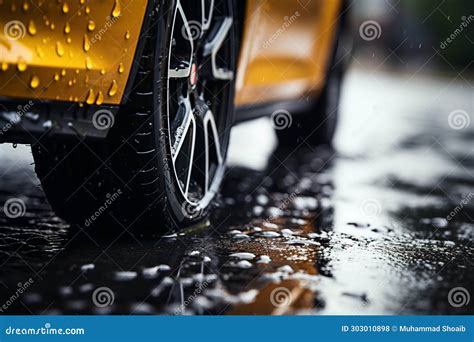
[[0, 0, 147, 104]]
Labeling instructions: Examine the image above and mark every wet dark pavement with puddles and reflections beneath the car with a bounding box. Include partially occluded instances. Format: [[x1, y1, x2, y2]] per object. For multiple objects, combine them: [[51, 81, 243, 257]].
[[0, 68, 474, 314]]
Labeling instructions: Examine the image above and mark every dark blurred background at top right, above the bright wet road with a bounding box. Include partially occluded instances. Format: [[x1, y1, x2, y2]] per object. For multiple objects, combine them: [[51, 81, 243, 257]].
[[352, 0, 474, 77]]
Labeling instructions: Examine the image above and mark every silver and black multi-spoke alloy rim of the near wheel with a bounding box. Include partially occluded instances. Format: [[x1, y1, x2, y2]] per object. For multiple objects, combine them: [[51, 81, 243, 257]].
[[166, 0, 234, 208]]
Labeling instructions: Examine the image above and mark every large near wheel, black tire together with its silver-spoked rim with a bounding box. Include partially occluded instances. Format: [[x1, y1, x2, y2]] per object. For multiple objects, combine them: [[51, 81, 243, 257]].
[[32, 0, 238, 232]]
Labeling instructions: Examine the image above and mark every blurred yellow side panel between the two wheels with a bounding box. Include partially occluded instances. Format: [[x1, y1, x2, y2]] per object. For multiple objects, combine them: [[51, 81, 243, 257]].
[[236, 0, 342, 105]]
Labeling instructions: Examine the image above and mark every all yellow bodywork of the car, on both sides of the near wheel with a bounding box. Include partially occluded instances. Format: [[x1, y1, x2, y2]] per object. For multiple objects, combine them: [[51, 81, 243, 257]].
[[0, 0, 342, 106]]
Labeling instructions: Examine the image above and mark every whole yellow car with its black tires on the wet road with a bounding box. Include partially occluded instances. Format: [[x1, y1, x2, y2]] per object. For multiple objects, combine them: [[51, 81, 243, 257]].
[[0, 0, 349, 232]]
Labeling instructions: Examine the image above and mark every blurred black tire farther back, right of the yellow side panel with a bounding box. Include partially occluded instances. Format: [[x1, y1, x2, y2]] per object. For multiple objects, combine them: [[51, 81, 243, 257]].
[[274, 10, 351, 149]]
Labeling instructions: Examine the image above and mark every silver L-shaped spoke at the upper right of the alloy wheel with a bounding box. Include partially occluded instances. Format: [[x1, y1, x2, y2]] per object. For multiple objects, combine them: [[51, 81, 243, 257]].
[[204, 17, 234, 81]]
